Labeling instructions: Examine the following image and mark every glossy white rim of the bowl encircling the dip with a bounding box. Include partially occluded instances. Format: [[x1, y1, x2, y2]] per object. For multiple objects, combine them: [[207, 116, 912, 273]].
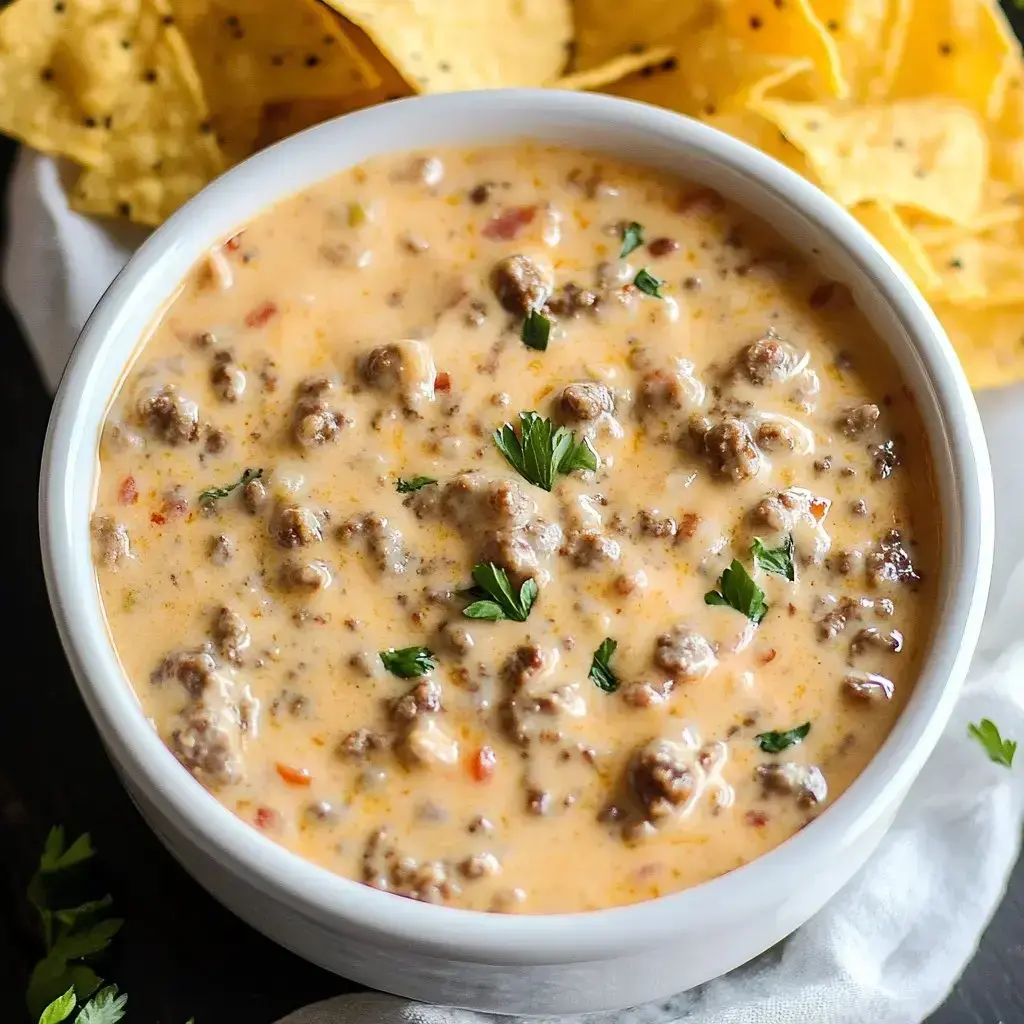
[[39, 89, 993, 965]]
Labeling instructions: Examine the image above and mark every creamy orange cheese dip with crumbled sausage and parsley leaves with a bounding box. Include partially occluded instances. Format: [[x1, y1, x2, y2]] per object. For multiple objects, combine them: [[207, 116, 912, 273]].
[[92, 145, 940, 913]]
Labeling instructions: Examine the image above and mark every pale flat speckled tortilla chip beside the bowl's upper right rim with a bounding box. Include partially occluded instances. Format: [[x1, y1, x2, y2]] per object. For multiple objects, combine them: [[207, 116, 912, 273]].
[[756, 99, 988, 223]]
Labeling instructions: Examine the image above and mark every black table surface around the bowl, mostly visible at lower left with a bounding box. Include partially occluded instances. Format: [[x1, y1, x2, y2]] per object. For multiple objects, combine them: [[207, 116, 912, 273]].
[[0, 14, 1024, 1024]]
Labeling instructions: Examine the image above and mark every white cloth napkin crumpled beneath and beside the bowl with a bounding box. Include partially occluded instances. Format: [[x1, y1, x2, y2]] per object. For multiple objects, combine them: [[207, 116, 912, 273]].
[[9, 152, 1024, 1024]]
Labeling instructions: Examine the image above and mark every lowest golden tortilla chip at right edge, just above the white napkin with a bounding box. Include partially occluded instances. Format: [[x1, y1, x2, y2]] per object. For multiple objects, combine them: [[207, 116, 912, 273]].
[[933, 302, 1024, 389]]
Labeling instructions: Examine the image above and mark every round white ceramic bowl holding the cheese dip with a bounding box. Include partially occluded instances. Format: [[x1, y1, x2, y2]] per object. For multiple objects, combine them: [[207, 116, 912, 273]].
[[40, 90, 992, 1013]]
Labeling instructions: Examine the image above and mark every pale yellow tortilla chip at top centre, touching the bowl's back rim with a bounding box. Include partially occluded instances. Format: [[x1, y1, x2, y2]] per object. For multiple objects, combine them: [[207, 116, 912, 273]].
[[327, 0, 572, 92]]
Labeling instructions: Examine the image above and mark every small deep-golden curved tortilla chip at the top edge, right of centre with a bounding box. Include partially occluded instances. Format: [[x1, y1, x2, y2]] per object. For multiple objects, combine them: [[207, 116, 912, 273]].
[[720, 0, 850, 99]]
